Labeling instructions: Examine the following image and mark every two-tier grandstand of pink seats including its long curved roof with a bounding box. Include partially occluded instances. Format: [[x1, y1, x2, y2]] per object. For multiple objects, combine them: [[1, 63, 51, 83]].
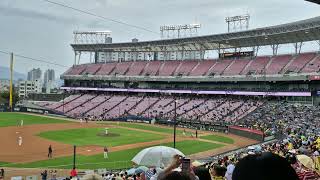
[[28, 17, 320, 134]]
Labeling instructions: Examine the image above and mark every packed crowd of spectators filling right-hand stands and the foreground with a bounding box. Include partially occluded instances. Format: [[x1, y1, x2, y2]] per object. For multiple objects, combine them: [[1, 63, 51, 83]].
[[27, 99, 320, 180]]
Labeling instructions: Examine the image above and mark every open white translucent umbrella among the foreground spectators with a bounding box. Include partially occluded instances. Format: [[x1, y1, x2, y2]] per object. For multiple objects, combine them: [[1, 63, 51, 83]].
[[131, 146, 185, 167]]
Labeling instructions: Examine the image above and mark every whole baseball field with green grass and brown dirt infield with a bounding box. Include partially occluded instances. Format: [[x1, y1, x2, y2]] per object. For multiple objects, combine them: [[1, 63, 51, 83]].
[[0, 113, 255, 169]]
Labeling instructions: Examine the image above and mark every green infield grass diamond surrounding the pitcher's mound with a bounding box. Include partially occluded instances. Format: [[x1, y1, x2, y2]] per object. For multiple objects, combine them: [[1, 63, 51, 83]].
[[38, 128, 165, 147]]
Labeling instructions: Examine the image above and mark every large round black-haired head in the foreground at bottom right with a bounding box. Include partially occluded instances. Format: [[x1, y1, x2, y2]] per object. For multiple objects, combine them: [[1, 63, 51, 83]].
[[232, 152, 299, 180]]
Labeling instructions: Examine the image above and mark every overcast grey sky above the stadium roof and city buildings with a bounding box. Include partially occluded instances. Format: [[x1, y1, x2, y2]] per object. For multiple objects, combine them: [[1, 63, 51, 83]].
[[0, 0, 320, 74]]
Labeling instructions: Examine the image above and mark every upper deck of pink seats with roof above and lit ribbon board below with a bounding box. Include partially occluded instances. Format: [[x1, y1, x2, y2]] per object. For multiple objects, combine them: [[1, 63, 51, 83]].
[[61, 17, 320, 104]]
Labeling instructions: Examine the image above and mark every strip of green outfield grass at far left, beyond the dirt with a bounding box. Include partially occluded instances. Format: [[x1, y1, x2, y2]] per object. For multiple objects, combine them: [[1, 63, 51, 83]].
[[0, 112, 69, 127]]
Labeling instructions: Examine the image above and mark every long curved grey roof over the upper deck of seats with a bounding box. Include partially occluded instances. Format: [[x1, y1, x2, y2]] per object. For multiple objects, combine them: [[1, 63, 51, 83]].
[[71, 16, 320, 52]]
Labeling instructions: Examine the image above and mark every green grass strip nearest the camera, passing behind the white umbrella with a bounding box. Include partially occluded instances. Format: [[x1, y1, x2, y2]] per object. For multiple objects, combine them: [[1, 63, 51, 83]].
[[8, 140, 223, 169]]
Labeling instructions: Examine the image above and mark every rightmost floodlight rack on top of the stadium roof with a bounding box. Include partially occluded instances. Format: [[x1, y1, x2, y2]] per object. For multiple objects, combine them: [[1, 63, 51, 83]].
[[225, 14, 250, 32]]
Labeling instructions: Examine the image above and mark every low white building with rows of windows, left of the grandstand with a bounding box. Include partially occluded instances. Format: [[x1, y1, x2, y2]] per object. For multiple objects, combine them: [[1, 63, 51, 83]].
[[19, 80, 42, 98]]
